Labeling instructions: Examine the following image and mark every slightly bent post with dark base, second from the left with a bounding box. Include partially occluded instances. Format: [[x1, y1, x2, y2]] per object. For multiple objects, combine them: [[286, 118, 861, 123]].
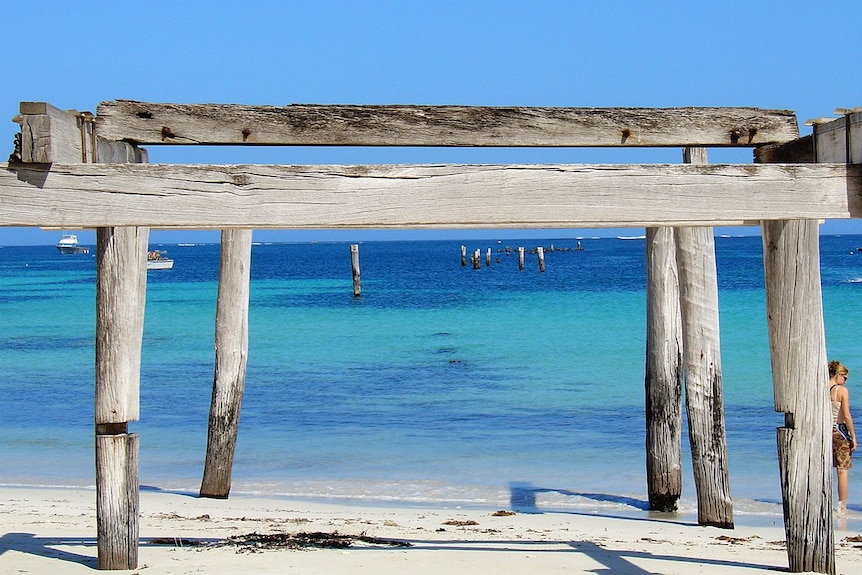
[[200, 229, 252, 499]]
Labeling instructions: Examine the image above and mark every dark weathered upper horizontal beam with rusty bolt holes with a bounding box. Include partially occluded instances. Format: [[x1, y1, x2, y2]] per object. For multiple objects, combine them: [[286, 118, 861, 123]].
[[96, 100, 799, 147]]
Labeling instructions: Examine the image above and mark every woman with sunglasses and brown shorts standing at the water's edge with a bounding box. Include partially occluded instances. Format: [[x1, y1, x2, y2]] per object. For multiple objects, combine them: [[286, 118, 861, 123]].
[[829, 361, 857, 515]]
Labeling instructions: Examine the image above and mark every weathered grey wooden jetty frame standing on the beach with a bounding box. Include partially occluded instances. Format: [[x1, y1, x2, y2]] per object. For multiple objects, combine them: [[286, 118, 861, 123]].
[[0, 100, 862, 573]]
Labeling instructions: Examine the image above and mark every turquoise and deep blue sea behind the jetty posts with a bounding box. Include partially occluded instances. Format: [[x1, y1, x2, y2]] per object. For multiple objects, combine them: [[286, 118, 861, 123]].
[[0, 236, 862, 520]]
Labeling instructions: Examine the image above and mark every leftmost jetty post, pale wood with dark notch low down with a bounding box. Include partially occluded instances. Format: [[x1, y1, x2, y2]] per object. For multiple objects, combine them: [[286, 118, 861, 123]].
[[95, 228, 149, 569]]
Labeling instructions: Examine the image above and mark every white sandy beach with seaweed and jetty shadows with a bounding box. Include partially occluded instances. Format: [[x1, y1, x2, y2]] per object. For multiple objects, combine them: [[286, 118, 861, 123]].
[[0, 487, 862, 575]]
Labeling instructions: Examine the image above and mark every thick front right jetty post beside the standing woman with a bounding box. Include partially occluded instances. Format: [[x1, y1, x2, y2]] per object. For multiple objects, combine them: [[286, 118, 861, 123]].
[[761, 220, 835, 574]]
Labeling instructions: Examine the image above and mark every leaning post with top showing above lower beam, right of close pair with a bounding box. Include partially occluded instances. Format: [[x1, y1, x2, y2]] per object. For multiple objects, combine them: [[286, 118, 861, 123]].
[[674, 148, 733, 529]]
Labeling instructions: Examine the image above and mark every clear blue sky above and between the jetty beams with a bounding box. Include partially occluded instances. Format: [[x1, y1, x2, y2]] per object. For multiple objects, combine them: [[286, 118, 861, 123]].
[[0, 0, 862, 245]]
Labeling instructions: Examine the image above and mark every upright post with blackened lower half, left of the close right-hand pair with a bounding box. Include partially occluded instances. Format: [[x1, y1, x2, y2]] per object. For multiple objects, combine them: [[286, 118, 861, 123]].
[[644, 227, 682, 511]]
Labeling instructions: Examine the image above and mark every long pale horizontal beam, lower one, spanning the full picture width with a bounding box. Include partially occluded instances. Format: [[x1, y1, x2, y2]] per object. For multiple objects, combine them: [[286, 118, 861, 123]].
[[0, 164, 862, 229]]
